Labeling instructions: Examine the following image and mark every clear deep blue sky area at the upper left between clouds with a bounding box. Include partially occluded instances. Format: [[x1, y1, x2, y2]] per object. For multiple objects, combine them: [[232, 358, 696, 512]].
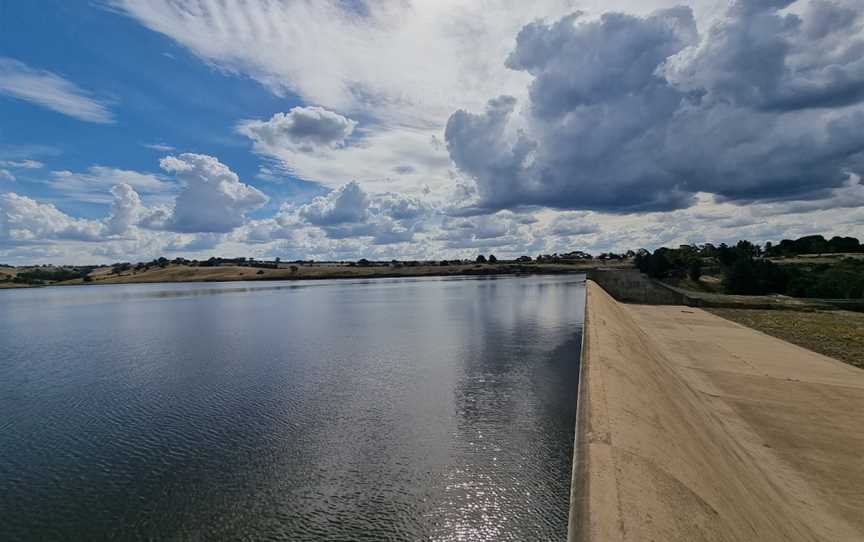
[[0, 0, 322, 218]]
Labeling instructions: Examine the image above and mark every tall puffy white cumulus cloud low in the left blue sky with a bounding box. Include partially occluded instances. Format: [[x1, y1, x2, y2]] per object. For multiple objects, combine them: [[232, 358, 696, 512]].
[[157, 153, 268, 233]]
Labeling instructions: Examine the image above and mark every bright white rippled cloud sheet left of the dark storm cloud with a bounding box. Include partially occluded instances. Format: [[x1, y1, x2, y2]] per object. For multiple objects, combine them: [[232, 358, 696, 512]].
[[112, 0, 717, 205]]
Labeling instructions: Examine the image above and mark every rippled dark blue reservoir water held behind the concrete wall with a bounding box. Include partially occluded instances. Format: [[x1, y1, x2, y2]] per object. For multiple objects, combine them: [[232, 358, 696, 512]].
[[0, 276, 584, 541]]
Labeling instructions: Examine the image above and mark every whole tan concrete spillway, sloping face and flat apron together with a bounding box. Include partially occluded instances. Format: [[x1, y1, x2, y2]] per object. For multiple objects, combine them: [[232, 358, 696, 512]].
[[570, 281, 864, 541]]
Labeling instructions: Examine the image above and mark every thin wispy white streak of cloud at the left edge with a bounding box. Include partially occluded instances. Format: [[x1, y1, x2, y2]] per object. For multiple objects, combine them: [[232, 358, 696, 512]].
[[0, 57, 114, 124]]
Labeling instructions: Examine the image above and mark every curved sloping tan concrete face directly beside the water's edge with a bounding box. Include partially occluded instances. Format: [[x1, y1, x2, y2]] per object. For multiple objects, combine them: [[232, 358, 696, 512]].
[[568, 280, 864, 542]]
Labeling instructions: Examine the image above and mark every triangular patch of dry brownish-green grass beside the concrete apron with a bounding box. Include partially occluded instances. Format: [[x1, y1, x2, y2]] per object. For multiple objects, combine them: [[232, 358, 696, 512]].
[[706, 309, 864, 368]]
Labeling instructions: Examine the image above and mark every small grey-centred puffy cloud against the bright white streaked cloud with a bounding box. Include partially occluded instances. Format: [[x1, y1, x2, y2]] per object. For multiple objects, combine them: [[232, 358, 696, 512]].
[[237, 107, 357, 153]]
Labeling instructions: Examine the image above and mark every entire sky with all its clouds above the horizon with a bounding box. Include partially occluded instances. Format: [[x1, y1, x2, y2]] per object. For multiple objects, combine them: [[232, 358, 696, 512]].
[[0, 0, 864, 265]]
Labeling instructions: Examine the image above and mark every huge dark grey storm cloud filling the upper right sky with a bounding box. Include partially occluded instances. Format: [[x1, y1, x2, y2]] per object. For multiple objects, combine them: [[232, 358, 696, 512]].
[[445, 0, 864, 213]]
